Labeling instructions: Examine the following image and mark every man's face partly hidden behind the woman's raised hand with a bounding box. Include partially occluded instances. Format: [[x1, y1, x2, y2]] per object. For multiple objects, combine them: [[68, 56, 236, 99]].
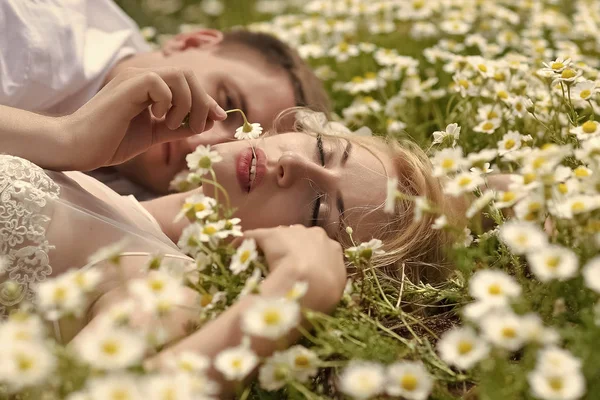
[[117, 46, 295, 193]]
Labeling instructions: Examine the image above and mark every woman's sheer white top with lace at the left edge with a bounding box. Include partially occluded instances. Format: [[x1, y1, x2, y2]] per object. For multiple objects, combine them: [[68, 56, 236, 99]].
[[0, 155, 188, 315]]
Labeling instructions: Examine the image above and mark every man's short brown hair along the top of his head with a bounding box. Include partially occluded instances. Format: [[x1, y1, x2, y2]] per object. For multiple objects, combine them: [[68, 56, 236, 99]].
[[221, 29, 331, 114]]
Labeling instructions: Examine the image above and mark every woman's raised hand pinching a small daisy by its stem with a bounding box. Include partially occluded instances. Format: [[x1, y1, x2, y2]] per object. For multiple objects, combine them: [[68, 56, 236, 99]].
[[59, 67, 227, 171]]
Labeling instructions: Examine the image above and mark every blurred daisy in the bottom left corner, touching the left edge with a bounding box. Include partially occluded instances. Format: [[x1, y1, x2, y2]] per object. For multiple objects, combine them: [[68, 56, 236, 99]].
[[0, 341, 56, 391]]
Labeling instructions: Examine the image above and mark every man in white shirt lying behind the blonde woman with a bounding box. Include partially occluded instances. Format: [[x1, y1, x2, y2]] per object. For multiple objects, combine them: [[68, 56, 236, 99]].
[[0, 0, 328, 199]]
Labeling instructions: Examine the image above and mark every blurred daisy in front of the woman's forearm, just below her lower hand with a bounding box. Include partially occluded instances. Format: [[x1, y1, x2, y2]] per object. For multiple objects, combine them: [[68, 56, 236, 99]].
[[242, 299, 300, 339]]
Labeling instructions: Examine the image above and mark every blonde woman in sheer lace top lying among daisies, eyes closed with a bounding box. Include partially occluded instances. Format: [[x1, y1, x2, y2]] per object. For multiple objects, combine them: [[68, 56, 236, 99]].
[[0, 69, 444, 390]]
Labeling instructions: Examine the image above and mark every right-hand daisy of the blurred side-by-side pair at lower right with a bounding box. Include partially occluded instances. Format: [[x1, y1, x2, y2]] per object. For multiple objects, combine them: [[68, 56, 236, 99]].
[[480, 310, 525, 351]]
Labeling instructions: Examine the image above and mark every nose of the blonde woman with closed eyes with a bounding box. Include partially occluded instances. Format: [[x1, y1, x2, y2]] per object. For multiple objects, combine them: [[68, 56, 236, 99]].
[[276, 152, 334, 188]]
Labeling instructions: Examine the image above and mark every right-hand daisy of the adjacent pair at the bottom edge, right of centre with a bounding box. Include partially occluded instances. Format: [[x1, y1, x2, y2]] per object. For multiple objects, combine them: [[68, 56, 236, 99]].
[[386, 361, 433, 400]]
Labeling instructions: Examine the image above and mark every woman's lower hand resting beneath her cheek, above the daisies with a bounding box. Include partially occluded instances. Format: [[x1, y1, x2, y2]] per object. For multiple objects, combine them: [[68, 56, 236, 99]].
[[244, 225, 346, 312]]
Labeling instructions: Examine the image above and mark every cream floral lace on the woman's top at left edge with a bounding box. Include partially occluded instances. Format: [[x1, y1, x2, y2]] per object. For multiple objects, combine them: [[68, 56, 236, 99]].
[[0, 155, 60, 315]]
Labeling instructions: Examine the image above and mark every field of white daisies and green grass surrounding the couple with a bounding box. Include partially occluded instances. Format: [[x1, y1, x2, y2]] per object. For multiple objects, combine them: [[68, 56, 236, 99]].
[[0, 0, 600, 400]]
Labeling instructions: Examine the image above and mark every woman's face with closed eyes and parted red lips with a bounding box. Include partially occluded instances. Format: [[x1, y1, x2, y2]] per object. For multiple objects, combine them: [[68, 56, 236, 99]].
[[209, 133, 393, 240]]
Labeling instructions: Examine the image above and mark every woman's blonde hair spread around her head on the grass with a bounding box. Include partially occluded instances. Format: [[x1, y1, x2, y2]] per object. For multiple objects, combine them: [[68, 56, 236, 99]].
[[275, 108, 457, 283]]
